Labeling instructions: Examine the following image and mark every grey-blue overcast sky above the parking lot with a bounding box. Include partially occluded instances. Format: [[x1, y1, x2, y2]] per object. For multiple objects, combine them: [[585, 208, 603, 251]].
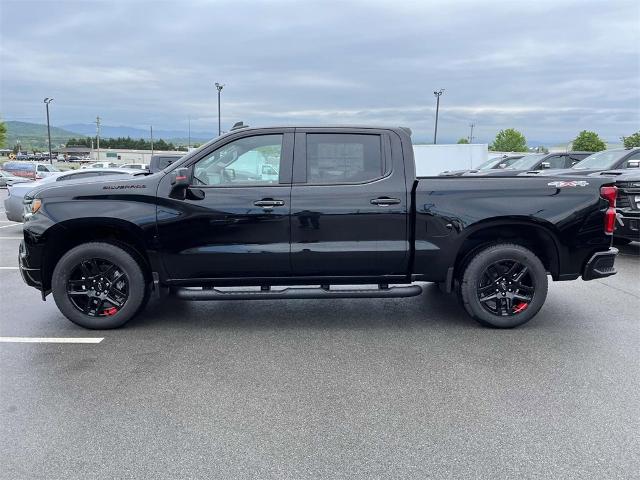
[[0, 0, 640, 142]]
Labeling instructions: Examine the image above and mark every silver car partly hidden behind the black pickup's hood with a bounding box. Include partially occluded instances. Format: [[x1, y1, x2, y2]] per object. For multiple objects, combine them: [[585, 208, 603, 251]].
[[4, 168, 141, 222]]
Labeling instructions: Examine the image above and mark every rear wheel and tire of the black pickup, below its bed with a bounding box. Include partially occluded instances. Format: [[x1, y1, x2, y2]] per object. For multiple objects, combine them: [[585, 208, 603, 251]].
[[460, 243, 549, 328]]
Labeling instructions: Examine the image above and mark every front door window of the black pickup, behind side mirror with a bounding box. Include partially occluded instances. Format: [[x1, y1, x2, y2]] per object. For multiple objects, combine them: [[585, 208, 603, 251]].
[[193, 134, 282, 186]]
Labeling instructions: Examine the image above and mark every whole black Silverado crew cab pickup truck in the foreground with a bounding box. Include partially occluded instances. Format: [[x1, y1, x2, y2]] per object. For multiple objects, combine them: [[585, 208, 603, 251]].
[[19, 127, 617, 329]]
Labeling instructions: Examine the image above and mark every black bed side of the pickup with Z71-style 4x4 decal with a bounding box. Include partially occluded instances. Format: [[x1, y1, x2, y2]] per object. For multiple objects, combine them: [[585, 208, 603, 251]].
[[414, 177, 613, 281]]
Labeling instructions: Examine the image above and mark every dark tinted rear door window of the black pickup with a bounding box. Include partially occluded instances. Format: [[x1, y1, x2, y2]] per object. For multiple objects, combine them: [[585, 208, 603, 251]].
[[307, 133, 384, 184]]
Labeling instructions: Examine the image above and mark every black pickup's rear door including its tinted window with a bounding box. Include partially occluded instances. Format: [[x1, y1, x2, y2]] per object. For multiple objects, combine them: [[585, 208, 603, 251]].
[[291, 128, 409, 277]]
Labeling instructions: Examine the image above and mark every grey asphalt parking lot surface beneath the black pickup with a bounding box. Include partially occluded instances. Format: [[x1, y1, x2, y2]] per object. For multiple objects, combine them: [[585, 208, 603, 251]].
[[0, 190, 640, 479]]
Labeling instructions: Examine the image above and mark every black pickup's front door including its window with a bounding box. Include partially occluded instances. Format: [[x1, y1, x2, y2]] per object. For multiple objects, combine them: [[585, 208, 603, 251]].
[[158, 129, 293, 280]]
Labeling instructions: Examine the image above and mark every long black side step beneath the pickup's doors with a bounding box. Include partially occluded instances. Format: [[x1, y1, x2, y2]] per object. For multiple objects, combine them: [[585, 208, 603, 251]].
[[174, 285, 422, 300]]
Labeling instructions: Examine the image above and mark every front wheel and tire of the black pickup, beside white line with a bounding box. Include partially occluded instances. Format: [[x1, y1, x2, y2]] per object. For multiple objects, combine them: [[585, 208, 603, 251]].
[[51, 242, 149, 330]]
